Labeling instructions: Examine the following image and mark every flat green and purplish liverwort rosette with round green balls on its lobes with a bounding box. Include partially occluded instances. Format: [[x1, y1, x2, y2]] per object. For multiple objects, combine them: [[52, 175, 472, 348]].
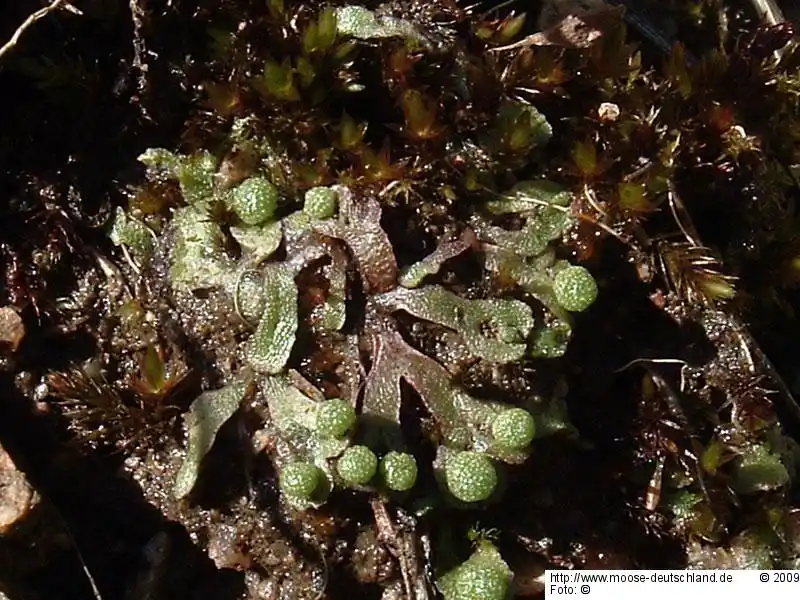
[[116, 8, 596, 502]]
